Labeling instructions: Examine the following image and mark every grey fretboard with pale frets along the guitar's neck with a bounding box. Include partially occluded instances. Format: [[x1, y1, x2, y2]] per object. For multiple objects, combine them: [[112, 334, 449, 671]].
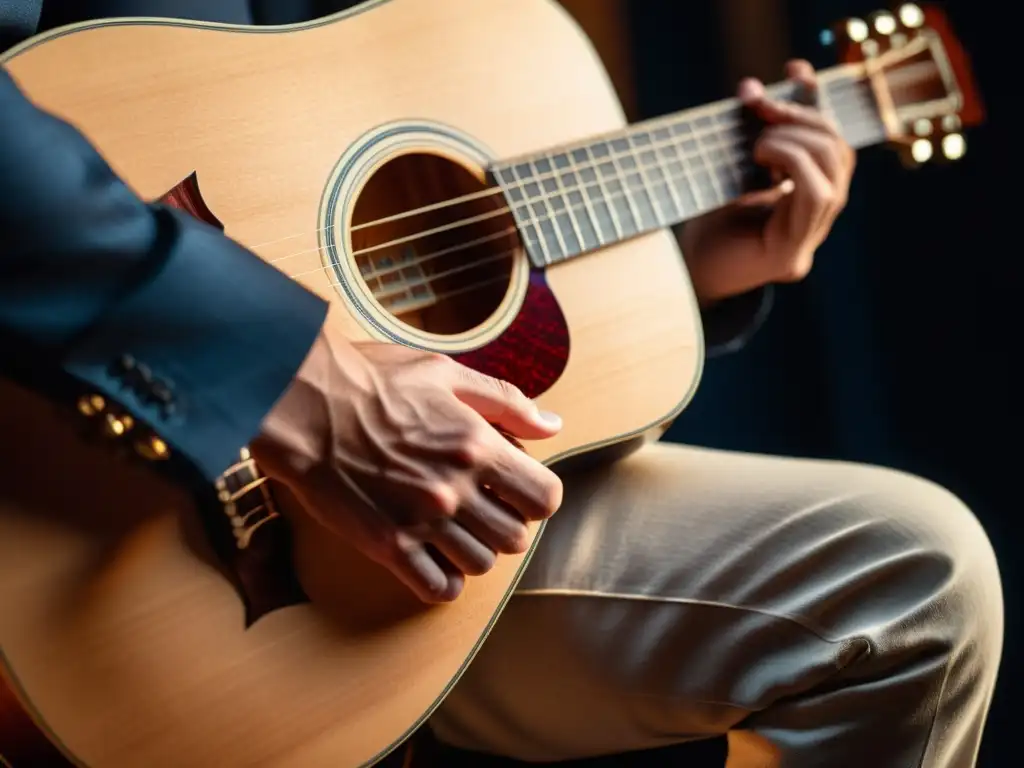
[[492, 68, 886, 266]]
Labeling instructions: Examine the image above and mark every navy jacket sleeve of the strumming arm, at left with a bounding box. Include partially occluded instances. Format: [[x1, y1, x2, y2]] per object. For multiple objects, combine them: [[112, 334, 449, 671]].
[[0, 68, 327, 481]]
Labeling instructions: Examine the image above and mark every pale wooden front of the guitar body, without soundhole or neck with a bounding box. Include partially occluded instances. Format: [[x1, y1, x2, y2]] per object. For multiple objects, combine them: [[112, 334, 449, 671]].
[[0, 0, 703, 768]]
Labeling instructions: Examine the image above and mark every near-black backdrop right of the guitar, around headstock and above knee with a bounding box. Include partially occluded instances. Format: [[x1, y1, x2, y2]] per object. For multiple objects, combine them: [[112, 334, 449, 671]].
[[626, 0, 1024, 768]]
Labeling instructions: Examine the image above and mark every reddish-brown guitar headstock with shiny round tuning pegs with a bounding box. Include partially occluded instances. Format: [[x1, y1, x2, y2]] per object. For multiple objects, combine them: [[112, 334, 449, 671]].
[[830, 3, 984, 165]]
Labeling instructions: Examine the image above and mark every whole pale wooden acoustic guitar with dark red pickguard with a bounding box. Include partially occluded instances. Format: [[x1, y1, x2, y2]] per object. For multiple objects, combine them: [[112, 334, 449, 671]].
[[0, 0, 981, 768]]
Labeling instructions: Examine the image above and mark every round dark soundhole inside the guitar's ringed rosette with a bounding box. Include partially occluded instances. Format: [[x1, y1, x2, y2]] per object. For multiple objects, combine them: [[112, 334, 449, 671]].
[[350, 153, 523, 335]]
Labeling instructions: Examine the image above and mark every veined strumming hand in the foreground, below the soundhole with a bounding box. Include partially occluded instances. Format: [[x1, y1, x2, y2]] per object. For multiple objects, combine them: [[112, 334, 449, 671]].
[[253, 330, 562, 602]]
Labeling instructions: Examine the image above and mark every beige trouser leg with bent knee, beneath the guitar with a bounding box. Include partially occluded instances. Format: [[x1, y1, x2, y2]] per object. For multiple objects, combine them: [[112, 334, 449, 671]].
[[432, 443, 1002, 768]]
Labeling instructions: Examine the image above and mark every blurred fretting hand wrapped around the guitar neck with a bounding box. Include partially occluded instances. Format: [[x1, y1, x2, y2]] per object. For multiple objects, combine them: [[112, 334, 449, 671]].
[[682, 60, 855, 304]]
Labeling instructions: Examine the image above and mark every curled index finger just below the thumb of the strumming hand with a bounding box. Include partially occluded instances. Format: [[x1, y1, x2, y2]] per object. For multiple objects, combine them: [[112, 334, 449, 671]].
[[478, 443, 562, 520]]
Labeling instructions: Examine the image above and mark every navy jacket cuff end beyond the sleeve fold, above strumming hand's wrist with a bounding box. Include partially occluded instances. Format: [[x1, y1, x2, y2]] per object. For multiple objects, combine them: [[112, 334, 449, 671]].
[[63, 206, 327, 482]]
